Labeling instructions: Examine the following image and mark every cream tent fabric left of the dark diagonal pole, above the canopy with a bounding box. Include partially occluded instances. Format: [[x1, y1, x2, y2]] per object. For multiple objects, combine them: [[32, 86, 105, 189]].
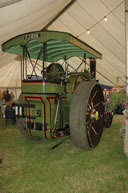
[[0, 0, 71, 67]]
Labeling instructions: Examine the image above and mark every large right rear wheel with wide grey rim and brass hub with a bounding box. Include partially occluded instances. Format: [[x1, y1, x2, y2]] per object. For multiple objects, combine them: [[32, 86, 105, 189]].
[[70, 81, 104, 149]]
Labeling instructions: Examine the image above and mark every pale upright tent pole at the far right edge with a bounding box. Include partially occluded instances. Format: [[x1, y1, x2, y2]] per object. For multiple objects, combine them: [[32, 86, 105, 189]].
[[124, 0, 128, 157]]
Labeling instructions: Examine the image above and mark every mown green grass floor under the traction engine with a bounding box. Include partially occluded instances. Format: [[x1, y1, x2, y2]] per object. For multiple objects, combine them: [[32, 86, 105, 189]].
[[0, 115, 128, 193]]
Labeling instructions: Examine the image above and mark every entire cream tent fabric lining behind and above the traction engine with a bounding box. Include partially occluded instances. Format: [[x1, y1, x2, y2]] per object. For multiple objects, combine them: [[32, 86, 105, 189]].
[[0, 0, 125, 94]]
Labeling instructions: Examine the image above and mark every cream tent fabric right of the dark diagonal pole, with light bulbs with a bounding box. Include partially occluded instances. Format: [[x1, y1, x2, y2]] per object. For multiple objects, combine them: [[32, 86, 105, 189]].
[[49, 0, 125, 85]]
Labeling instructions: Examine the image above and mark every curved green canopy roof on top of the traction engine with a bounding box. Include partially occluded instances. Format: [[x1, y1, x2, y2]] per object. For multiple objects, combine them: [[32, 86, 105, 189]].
[[2, 31, 102, 62]]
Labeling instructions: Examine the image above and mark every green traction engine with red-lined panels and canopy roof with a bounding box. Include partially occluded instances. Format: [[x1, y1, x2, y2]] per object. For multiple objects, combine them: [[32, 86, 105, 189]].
[[2, 31, 104, 149]]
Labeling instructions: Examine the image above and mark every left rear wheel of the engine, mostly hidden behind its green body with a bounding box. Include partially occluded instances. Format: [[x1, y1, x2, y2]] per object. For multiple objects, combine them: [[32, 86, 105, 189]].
[[16, 94, 43, 141]]
